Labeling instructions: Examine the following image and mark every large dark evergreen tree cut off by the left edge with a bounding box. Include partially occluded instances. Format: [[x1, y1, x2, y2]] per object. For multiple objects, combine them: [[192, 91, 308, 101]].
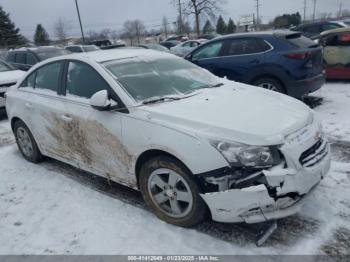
[[0, 6, 26, 47]]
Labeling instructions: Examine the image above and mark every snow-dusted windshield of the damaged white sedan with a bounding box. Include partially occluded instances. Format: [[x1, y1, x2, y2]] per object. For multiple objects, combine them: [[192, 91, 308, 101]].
[[104, 57, 220, 102]]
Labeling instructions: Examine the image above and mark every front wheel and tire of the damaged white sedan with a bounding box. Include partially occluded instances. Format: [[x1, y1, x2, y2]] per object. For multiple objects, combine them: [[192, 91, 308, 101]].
[[139, 156, 207, 227]]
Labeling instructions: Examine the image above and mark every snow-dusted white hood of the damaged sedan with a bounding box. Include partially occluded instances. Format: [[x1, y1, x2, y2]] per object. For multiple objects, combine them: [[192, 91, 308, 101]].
[[144, 80, 313, 146]]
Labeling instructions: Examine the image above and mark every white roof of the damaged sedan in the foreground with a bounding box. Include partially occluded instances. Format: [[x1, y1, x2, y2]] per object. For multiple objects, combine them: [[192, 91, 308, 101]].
[[48, 48, 177, 63]]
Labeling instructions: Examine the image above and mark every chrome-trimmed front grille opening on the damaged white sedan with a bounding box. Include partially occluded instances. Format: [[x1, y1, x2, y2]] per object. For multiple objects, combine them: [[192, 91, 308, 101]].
[[299, 139, 328, 167]]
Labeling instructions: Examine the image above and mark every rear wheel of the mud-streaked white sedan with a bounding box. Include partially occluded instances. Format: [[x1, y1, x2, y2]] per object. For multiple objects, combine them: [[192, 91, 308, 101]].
[[13, 120, 43, 163]]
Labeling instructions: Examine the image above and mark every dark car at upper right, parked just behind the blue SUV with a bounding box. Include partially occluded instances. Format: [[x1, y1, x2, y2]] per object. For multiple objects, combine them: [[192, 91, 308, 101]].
[[291, 21, 349, 39]]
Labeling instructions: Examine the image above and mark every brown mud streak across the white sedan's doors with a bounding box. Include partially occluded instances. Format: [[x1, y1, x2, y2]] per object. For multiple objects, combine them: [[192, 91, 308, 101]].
[[44, 113, 137, 188]]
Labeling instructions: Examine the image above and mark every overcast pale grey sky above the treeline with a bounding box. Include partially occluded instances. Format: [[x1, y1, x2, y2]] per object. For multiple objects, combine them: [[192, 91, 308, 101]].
[[0, 0, 350, 38]]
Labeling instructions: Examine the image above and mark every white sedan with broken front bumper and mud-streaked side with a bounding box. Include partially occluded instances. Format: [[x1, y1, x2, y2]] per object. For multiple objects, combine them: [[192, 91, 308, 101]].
[[6, 49, 330, 227]]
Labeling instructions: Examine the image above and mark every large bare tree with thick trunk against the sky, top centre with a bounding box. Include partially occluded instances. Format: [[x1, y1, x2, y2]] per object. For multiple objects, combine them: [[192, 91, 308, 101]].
[[180, 0, 225, 36]]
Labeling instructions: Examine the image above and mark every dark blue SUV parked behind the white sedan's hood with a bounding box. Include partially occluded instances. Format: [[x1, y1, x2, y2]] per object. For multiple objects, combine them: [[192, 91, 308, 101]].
[[185, 31, 325, 98]]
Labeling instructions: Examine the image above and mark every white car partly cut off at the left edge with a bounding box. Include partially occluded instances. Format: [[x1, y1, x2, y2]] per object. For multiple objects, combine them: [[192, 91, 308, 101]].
[[0, 60, 25, 111]]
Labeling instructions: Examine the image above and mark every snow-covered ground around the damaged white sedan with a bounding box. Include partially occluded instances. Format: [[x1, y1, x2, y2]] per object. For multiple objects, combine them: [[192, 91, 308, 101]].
[[0, 83, 350, 255]]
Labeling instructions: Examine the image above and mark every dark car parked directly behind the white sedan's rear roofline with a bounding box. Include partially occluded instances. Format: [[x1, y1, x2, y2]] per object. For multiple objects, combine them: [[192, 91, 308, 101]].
[[6, 46, 70, 71]]
